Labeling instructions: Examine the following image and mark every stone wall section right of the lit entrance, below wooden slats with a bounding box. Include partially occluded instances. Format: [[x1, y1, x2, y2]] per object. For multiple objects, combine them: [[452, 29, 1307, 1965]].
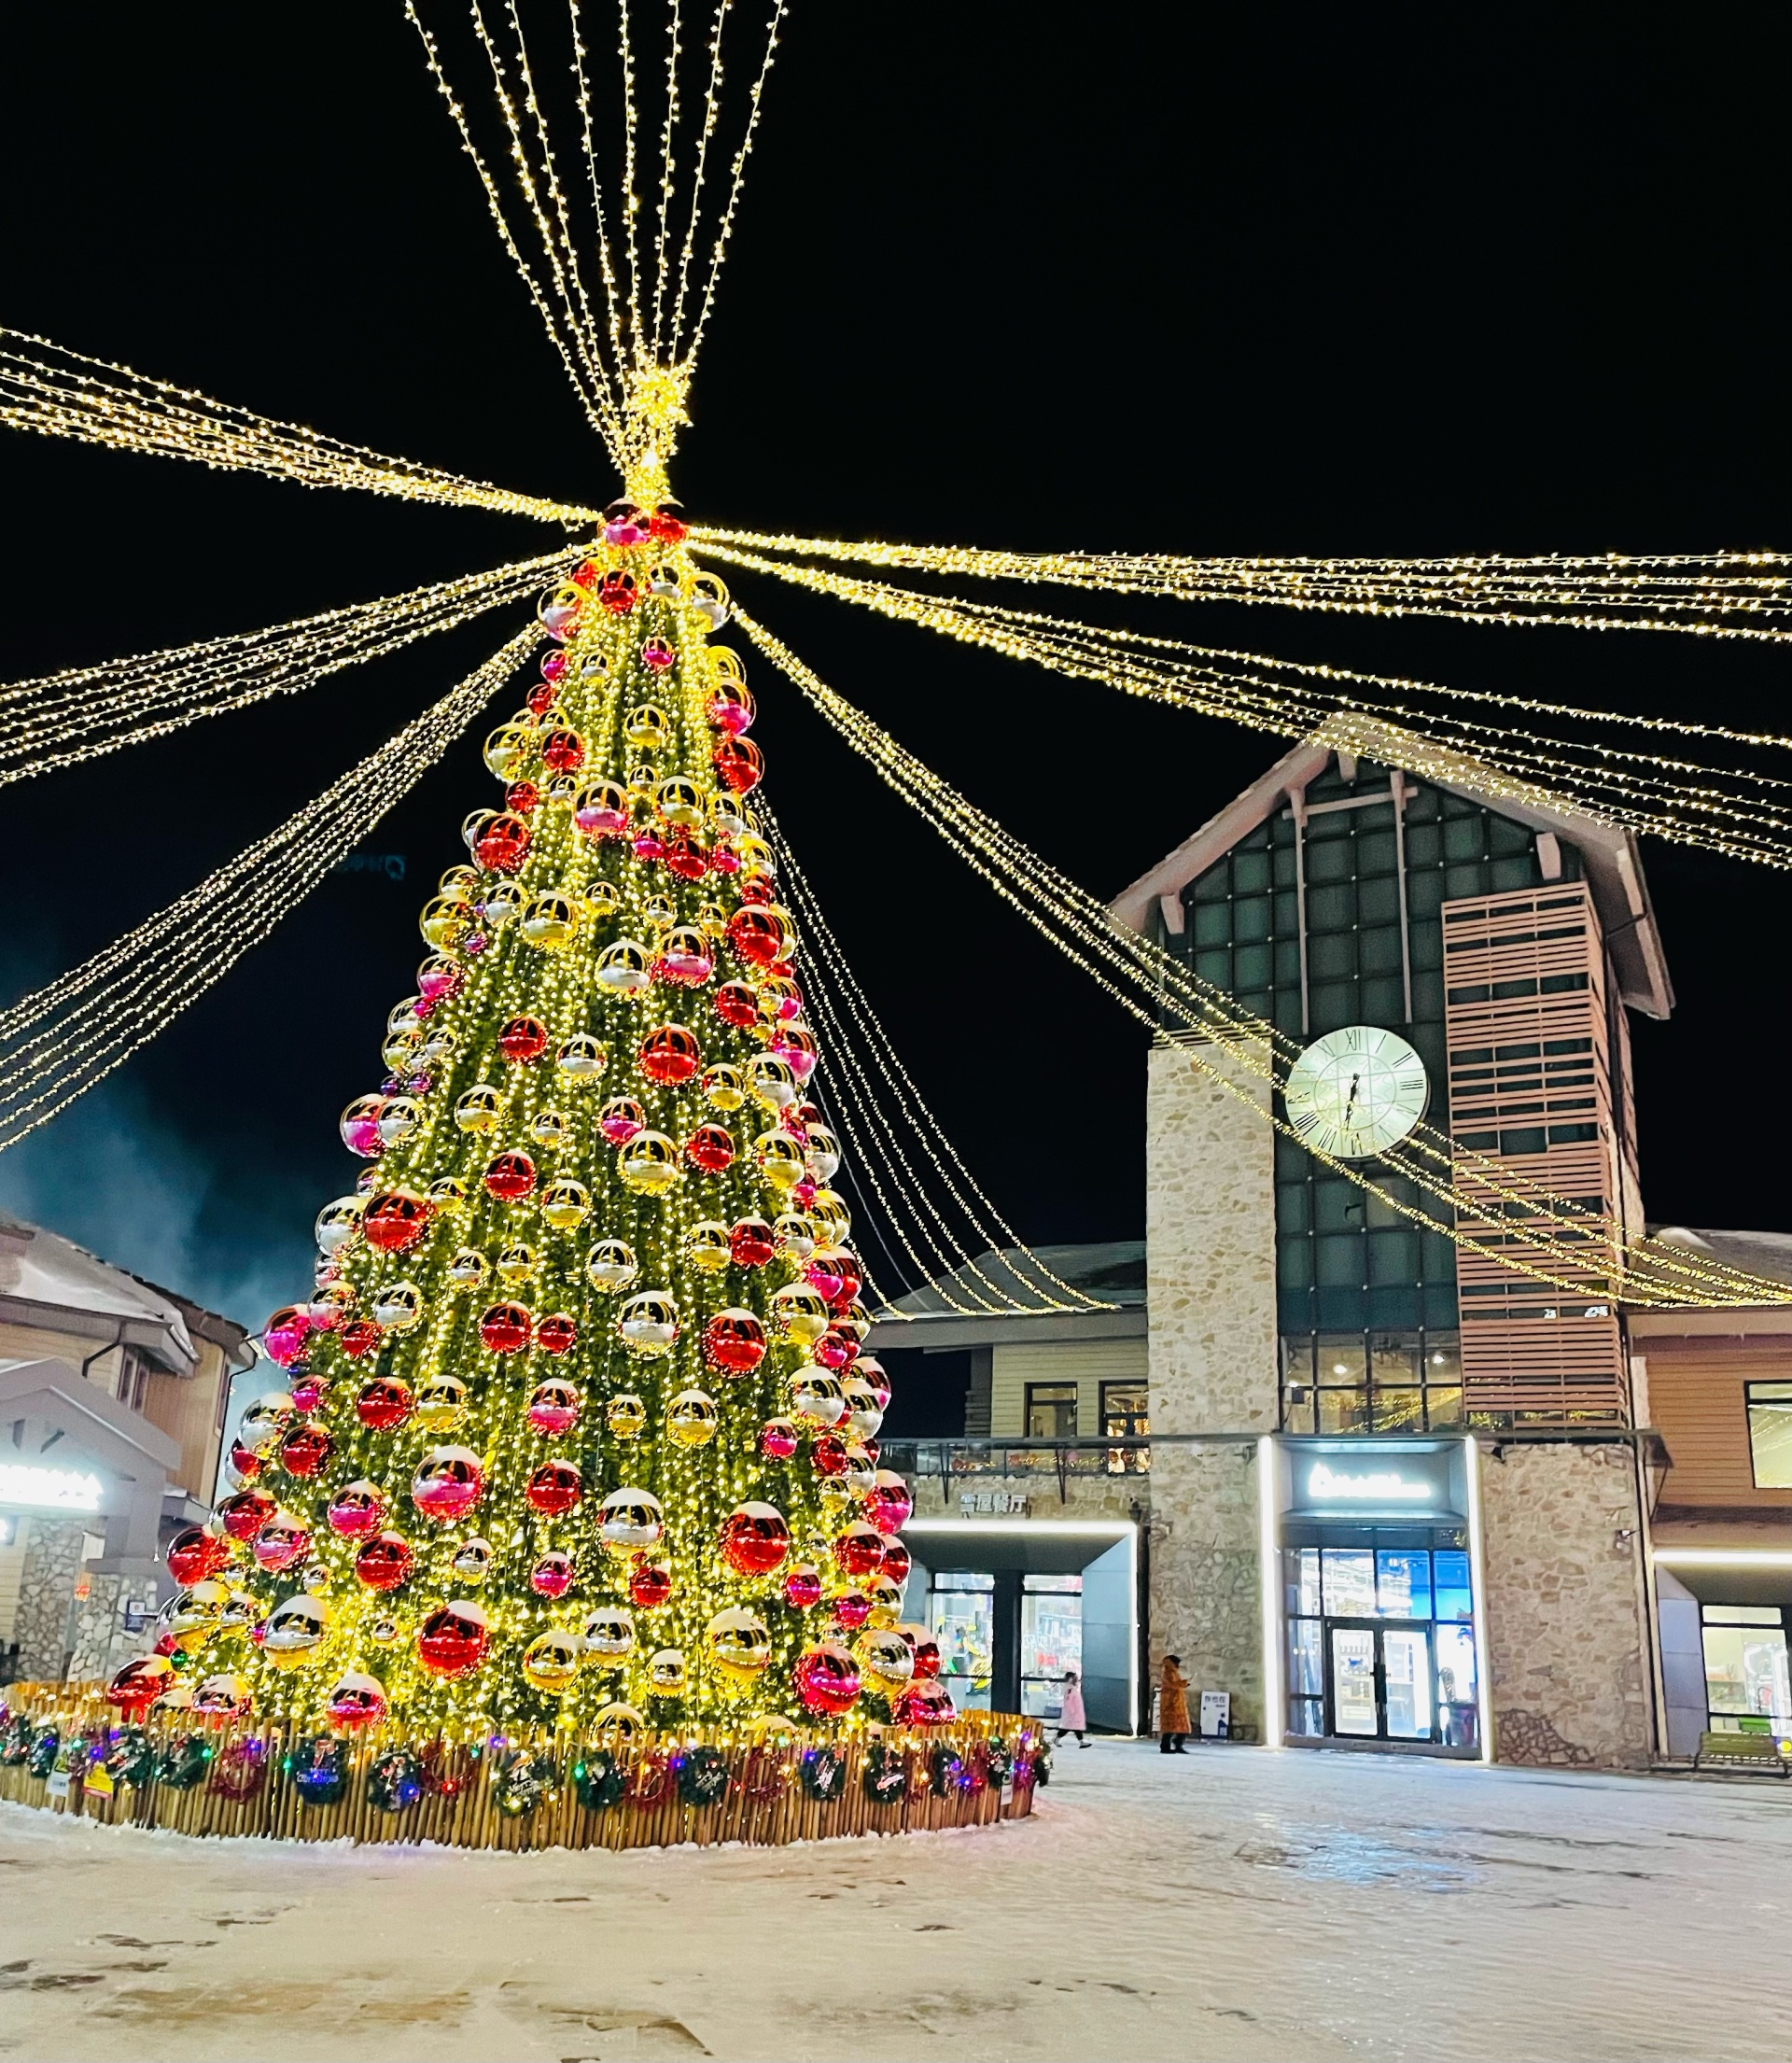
[[1480, 1442, 1654, 1770]]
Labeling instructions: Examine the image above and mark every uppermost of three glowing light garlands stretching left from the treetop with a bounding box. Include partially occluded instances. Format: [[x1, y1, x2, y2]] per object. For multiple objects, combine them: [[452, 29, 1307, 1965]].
[[0, 328, 598, 526]]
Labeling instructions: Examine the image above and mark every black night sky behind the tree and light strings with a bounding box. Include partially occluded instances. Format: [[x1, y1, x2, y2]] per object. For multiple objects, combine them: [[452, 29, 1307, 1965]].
[[0, 0, 1792, 1369]]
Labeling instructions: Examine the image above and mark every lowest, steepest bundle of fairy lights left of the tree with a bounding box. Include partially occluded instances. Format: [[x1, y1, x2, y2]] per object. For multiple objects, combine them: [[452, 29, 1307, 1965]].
[[0, 623, 542, 1147]]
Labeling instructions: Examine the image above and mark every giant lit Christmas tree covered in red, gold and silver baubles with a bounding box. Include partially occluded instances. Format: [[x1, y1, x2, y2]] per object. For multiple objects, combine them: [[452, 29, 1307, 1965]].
[[141, 501, 928, 1741]]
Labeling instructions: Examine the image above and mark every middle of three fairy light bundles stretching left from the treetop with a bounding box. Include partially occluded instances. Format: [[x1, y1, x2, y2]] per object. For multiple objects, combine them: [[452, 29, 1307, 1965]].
[[0, 551, 565, 786]]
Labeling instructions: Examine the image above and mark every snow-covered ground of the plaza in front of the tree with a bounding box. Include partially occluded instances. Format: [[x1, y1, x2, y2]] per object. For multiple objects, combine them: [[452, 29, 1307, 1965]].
[[0, 1743, 1792, 2063]]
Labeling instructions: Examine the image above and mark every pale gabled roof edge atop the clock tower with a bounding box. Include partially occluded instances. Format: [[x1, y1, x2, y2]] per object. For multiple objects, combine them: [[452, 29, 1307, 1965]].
[[1107, 726, 1674, 1017]]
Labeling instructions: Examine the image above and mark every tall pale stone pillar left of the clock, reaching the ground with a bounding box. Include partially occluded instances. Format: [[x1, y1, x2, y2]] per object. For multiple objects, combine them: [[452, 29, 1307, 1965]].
[[1144, 1044, 1279, 1739]]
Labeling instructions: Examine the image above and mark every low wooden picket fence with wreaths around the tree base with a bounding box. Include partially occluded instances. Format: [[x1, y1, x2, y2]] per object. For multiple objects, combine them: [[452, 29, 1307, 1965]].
[[0, 1683, 1045, 1853]]
